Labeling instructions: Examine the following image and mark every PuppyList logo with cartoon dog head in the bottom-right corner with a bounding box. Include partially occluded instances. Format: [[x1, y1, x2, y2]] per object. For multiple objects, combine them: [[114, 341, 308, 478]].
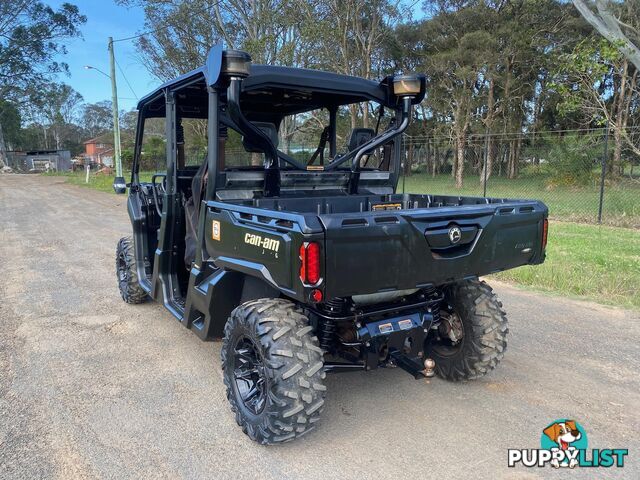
[[508, 418, 629, 468]]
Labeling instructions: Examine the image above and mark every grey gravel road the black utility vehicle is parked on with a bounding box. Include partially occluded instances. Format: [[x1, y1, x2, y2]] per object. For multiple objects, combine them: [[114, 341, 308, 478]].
[[0, 175, 640, 480]]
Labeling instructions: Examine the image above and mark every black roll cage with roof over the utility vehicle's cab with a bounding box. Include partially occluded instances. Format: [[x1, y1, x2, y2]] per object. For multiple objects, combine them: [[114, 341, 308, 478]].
[[126, 45, 425, 199]]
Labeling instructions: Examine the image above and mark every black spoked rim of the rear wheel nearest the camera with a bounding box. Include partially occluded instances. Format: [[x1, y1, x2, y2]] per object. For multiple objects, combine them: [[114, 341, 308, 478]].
[[233, 337, 267, 415]]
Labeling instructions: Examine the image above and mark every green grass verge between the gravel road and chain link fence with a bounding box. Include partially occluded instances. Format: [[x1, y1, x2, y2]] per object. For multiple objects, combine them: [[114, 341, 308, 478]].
[[494, 222, 640, 308]]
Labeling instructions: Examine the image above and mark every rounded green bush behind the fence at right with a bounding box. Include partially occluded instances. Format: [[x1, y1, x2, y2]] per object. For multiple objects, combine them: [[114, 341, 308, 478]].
[[542, 135, 602, 187]]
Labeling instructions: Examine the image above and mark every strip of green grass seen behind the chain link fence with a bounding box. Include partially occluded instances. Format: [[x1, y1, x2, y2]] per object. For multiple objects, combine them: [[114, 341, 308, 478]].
[[399, 173, 640, 228]]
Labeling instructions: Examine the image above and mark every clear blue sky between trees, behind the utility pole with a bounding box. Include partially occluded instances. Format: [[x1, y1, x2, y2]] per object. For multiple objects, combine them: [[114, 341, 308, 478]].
[[46, 0, 159, 110]]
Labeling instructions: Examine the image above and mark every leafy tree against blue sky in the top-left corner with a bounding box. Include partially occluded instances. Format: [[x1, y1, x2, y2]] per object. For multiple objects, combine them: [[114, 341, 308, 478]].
[[0, 0, 86, 167]]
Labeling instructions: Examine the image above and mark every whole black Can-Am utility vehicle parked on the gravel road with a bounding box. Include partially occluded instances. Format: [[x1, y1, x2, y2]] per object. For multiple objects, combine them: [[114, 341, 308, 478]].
[[114, 46, 547, 444]]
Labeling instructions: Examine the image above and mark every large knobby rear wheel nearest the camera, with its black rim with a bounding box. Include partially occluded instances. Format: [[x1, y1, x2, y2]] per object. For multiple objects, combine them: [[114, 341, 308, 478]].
[[221, 299, 326, 445]]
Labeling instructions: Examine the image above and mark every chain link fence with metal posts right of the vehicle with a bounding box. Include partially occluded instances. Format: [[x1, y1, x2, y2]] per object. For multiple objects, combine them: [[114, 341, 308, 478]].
[[399, 129, 640, 229]]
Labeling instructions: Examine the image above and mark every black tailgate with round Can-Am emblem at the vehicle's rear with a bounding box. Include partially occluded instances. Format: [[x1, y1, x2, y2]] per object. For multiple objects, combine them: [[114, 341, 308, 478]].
[[320, 201, 547, 298]]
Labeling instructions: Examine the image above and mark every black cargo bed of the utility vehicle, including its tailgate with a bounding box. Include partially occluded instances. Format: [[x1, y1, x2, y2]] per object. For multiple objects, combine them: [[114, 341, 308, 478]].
[[208, 194, 547, 298]]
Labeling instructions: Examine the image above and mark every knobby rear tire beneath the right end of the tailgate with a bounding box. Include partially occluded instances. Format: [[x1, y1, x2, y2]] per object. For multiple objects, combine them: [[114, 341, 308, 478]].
[[425, 280, 509, 381]]
